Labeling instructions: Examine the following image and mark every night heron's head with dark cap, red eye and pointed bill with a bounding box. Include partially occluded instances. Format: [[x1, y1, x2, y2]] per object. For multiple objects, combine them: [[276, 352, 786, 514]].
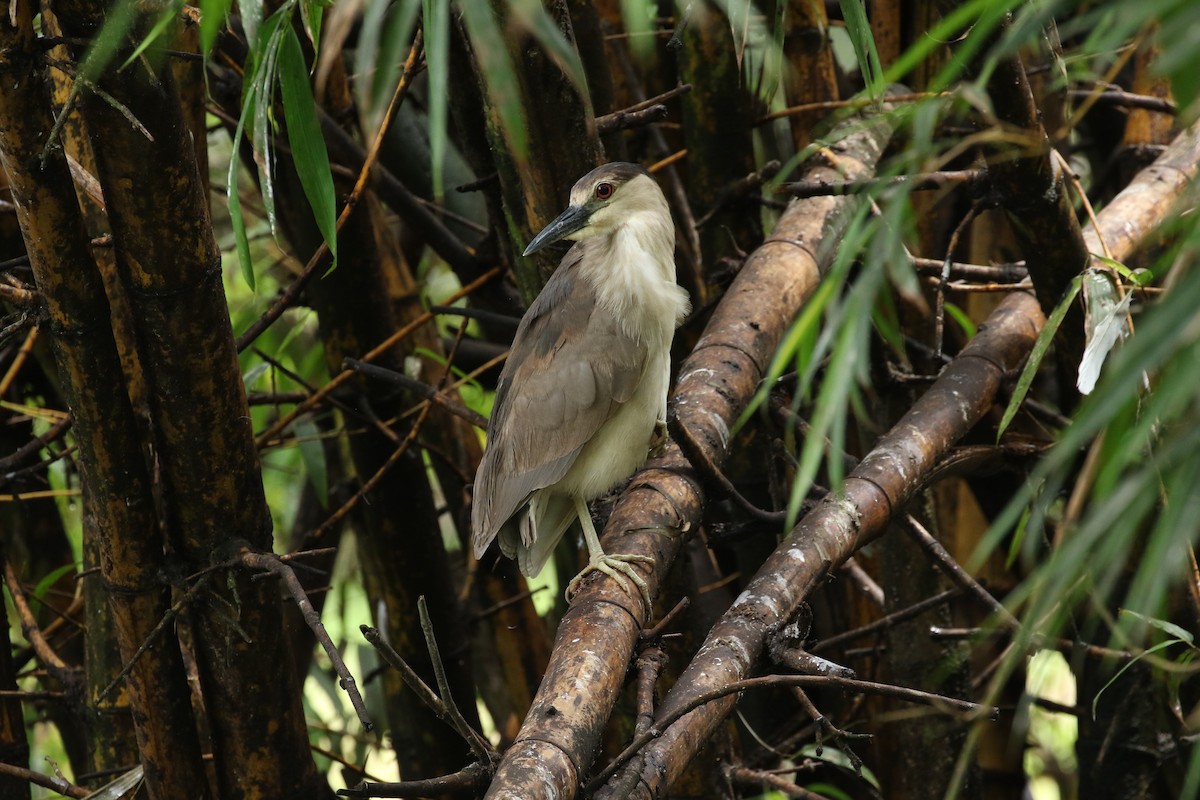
[[523, 161, 671, 255]]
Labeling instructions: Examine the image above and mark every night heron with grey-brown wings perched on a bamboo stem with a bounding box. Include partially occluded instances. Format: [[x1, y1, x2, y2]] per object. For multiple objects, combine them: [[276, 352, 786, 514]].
[[472, 163, 688, 610]]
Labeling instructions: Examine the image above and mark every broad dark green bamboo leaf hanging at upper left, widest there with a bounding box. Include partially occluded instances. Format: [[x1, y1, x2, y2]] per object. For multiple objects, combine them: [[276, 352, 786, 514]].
[[280, 25, 337, 264]]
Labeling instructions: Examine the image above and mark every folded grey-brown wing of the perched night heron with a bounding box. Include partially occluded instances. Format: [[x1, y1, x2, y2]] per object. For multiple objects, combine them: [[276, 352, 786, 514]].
[[472, 241, 646, 558]]
